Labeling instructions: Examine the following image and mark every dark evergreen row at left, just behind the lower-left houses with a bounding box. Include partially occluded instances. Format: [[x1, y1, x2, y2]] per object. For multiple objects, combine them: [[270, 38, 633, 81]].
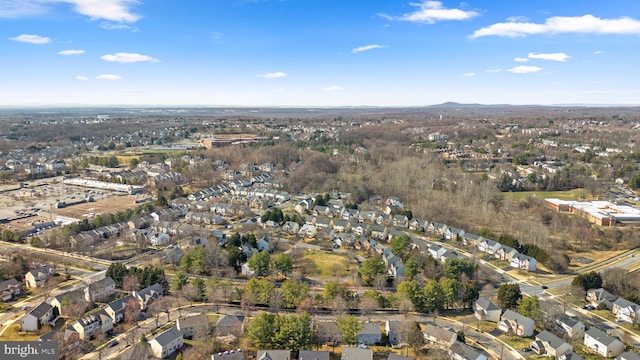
[[105, 262, 169, 290]]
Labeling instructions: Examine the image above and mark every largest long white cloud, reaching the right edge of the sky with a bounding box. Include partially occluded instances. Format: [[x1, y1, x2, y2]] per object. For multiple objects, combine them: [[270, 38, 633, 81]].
[[471, 15, 640, 38]]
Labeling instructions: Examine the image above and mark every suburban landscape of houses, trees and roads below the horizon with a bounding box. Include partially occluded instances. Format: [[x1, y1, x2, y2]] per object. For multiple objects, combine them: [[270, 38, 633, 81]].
[[0, 103, 640, 360]]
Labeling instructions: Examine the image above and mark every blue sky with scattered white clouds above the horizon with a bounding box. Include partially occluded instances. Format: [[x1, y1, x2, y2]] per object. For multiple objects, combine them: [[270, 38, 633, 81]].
[[0, 0, 640, 106]]
